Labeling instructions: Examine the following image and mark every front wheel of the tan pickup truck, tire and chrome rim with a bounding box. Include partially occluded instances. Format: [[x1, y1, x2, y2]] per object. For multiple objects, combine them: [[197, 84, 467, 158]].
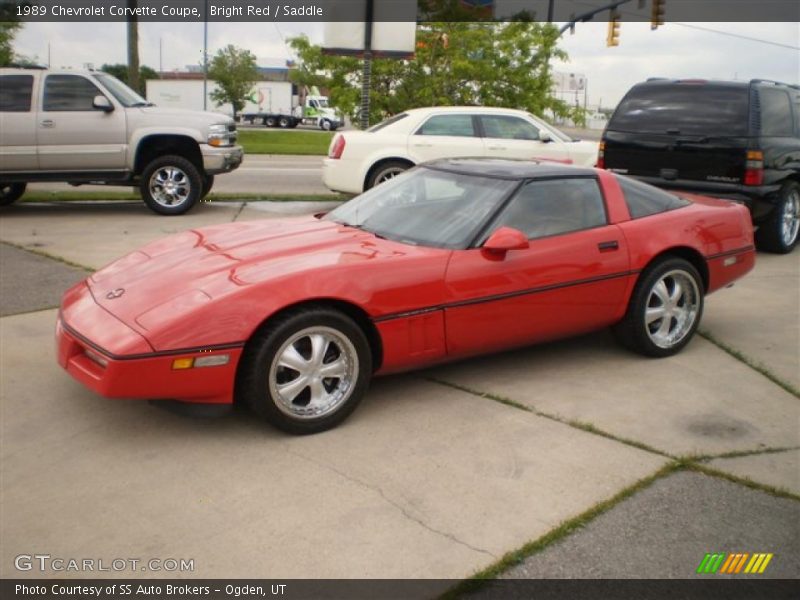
[[139, 155, 203, 215]]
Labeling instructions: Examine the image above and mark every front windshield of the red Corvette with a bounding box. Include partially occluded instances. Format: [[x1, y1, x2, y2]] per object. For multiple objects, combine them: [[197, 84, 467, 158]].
[[325, 167, 517, 248]]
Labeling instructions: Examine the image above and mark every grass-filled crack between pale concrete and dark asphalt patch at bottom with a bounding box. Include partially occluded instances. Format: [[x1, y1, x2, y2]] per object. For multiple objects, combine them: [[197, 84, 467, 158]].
[[439, 461, 683, 600]]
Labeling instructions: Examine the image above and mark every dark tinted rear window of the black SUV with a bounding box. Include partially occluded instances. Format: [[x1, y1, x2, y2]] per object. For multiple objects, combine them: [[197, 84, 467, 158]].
[[608, 83, 749, 137]]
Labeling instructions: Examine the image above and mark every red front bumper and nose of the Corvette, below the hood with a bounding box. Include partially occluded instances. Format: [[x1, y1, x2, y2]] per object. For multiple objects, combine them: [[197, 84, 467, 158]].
[[55, 284, 242, 404]]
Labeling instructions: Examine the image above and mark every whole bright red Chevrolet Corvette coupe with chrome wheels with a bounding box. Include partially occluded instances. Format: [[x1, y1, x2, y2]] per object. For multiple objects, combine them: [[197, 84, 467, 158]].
[[57, 159, 754, 433]]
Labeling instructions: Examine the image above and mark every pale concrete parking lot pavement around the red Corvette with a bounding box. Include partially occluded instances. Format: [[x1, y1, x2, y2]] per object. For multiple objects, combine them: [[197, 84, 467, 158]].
[[0, 197, 800, 591]]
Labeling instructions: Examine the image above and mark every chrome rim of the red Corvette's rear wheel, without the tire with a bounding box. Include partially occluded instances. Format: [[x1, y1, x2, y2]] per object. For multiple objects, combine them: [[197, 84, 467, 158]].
[[644, 270, 700, 349]]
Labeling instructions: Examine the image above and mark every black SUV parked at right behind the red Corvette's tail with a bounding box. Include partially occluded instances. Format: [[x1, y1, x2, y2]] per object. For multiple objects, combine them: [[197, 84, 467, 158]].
[[598, 79, 800, 253]]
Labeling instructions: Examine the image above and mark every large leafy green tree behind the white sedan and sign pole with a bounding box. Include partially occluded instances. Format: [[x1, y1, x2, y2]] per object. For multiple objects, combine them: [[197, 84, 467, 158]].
[[290, 22, 576, 123]]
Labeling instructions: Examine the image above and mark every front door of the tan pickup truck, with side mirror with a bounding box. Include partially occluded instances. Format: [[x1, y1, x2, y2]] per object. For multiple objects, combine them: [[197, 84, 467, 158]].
[[36, 74, 127, 173]]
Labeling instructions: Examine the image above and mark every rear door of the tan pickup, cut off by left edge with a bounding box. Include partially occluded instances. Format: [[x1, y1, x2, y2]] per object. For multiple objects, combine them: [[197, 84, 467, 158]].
[[0, 74, 38, 172]]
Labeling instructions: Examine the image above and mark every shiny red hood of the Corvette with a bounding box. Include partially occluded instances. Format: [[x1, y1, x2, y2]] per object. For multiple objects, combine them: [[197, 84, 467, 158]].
[[88, 217, 444, 336]]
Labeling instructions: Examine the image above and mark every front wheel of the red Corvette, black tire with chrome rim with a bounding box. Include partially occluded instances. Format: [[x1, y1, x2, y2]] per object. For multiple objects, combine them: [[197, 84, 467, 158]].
[[236, 307, 372, 435]]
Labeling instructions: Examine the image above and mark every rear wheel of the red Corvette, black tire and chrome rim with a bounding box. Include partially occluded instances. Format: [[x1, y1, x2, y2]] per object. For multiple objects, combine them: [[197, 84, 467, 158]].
[[613, 258, 703, 358]]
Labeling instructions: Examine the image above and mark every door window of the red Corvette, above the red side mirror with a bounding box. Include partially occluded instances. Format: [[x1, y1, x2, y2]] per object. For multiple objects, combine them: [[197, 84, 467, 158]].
[[491, 177, 607, 239]]
